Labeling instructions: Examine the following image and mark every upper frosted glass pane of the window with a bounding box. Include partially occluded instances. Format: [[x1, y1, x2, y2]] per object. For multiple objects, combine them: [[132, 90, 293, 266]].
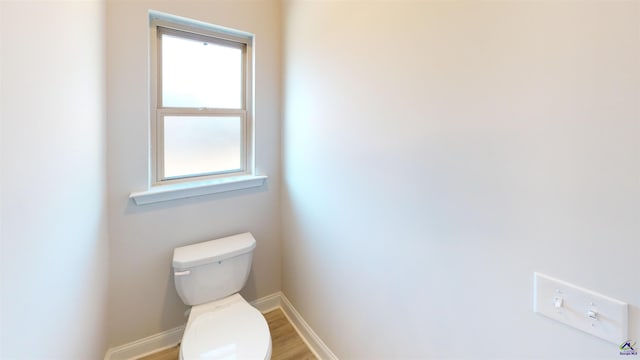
[[162, 34, 242, 109]]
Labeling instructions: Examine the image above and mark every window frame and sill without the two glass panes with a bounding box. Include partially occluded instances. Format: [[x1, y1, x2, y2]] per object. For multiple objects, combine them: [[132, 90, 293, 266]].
[[130, 11, 267, 205]]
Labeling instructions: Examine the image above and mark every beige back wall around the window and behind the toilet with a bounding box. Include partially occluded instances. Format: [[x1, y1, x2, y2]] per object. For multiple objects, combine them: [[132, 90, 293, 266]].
[[107, 0, 281, 346]]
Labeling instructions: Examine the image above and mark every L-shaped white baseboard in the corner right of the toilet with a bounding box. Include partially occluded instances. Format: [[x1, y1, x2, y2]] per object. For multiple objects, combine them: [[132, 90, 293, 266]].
[[251, 292, 338, 360]]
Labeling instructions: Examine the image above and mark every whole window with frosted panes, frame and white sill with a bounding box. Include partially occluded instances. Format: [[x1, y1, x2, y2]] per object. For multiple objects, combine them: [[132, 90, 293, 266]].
[[131, 11, 266, 204]]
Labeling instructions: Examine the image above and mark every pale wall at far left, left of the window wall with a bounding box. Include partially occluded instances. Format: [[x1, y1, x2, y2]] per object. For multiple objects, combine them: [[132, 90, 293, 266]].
[[0, 1, 108, 360]]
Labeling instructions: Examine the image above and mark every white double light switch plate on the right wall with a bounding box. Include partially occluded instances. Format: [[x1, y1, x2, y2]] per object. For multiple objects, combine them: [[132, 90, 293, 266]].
[[533, 273, 629, 345]]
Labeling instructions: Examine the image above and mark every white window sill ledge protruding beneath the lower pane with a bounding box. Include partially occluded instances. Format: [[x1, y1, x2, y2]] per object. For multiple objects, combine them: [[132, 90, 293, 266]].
[[129, 175, 268, 205]]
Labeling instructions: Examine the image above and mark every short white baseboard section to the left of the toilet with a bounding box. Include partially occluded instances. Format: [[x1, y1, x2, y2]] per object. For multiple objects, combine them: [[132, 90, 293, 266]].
[[104, 325, 184, 360]]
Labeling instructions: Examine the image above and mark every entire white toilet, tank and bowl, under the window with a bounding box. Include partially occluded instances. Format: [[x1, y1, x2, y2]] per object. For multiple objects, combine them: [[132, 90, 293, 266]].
[[173, 233, 271, 360]]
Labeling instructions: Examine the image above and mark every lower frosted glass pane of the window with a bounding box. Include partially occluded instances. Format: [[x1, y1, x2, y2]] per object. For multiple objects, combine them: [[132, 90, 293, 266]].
[[164, 116, 242, 178]]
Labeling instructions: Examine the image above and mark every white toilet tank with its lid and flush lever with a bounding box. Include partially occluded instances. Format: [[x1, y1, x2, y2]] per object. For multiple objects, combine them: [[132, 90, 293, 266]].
[[173, 233, 256, 306]]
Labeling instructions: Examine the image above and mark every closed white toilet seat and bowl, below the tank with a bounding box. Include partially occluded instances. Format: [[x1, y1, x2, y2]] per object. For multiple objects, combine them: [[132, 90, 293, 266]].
[[180, 294, 271, 360]]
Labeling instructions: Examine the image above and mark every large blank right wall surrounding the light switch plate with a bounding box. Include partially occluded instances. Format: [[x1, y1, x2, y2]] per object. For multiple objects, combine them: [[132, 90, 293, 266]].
[[282, 0, 640, 359]]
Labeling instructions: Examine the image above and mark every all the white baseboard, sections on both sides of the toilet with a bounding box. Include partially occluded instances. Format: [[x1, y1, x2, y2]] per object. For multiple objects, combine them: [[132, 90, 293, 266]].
[[104, 292, 338, 360]]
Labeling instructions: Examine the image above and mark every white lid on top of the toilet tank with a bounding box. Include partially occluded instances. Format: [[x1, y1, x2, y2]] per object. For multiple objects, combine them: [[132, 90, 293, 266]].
[[173, 232, 256, 269]]
